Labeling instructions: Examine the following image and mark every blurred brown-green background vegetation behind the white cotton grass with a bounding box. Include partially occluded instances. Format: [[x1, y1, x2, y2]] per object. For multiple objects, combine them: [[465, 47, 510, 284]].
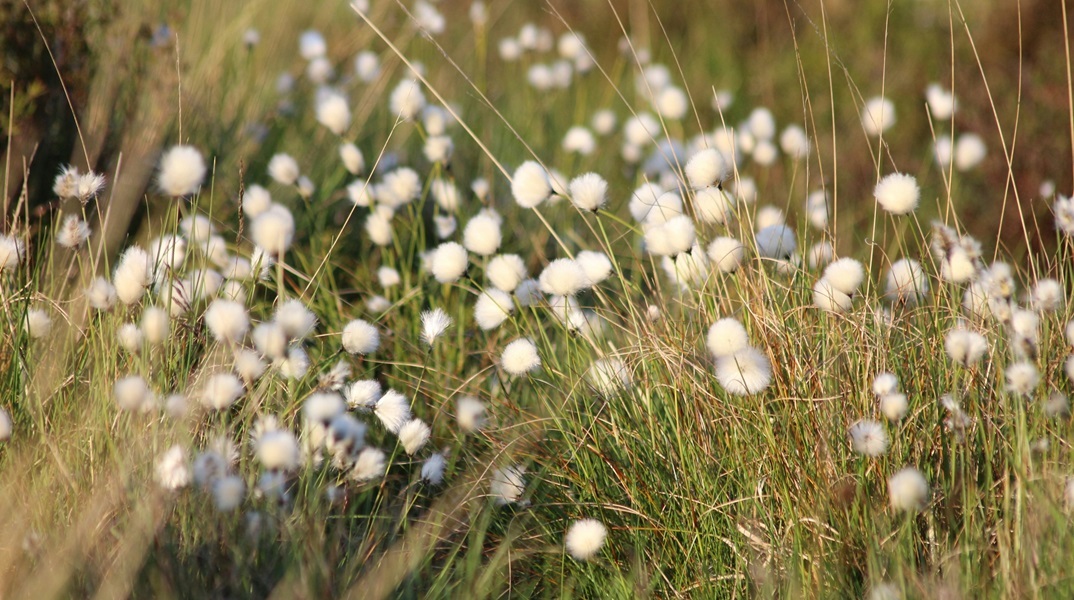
[[0, 0, 1072, 264]]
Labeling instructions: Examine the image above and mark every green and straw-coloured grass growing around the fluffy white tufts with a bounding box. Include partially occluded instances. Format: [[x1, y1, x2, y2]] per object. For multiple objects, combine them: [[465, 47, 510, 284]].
[[0, 1, 1074, 598]]
